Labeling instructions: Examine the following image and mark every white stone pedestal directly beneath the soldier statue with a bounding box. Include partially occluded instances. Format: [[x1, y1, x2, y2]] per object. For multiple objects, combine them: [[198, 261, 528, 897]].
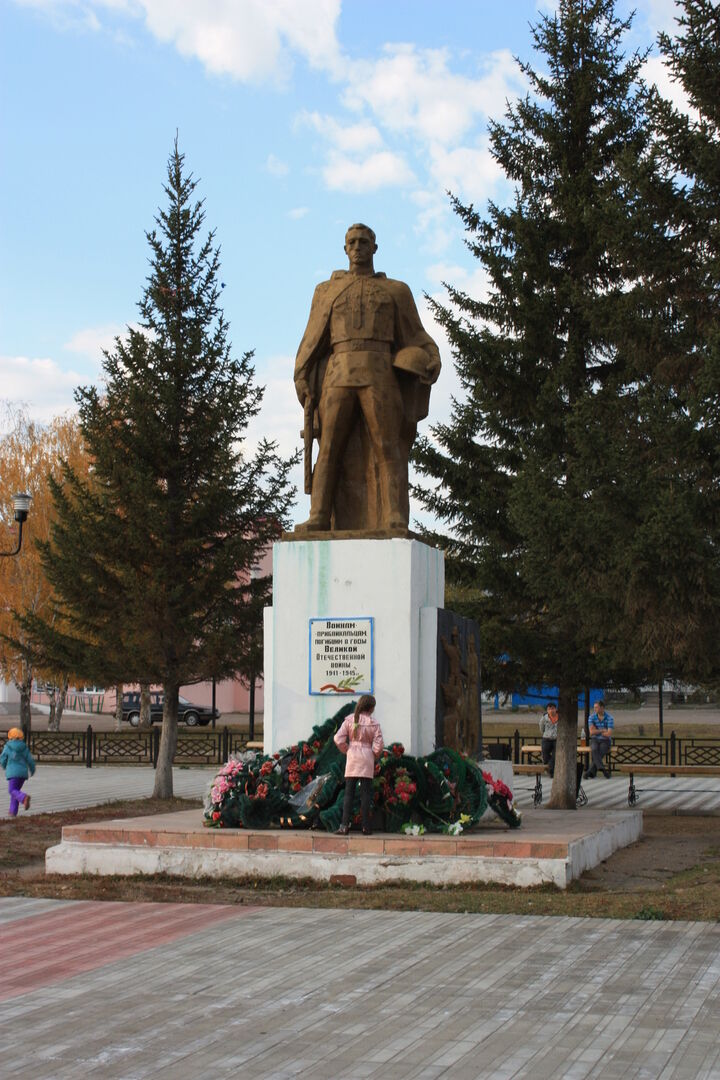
[[263, 539, 445, 755]]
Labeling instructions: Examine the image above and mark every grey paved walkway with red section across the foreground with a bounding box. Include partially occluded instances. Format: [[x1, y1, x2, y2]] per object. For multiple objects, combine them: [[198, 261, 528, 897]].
[[0, 899, 720, 1080]]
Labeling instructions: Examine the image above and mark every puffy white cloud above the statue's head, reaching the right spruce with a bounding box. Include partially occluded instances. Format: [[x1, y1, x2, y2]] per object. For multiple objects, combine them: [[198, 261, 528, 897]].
[[298, 44, 525, 203]]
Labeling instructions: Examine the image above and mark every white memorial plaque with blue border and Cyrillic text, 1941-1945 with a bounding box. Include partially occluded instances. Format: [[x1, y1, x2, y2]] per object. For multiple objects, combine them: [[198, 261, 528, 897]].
[[310, 618, 373, 696]]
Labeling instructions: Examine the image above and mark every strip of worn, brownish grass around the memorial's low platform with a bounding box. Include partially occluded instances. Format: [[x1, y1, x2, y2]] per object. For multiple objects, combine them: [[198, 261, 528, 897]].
[[0, 799, 720, 921]]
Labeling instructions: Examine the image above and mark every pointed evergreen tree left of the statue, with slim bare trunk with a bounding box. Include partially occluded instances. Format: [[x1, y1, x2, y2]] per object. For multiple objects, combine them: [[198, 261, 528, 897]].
[[25, 140, 293, 798]]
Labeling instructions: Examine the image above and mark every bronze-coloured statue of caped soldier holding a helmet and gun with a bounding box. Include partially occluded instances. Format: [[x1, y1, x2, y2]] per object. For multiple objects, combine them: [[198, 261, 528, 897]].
[[295, 225, 440, 536]]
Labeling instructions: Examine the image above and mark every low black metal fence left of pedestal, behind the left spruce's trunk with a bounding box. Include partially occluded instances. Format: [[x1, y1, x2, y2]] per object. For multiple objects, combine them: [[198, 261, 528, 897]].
[[0, 724, 253, 769]]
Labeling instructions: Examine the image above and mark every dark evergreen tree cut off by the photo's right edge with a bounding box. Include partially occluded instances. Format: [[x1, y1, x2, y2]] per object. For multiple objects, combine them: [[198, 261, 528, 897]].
[[651, 0, 720, 685]]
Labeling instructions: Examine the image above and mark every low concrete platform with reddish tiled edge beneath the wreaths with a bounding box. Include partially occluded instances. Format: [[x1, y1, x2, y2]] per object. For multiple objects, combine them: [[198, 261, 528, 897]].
[[45, 810, 642, 889]]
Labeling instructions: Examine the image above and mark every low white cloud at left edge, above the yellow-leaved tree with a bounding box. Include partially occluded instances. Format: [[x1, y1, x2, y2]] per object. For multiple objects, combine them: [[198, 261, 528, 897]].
[[0, 356, 92, 422]]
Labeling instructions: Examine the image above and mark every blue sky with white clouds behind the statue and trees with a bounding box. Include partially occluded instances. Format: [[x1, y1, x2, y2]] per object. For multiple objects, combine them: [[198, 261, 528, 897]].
[[0, 0, 675, 517]]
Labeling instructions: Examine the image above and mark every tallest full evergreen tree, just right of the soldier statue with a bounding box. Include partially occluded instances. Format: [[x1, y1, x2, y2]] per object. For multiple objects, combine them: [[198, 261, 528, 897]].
[[417, 0, 686, 808]]
